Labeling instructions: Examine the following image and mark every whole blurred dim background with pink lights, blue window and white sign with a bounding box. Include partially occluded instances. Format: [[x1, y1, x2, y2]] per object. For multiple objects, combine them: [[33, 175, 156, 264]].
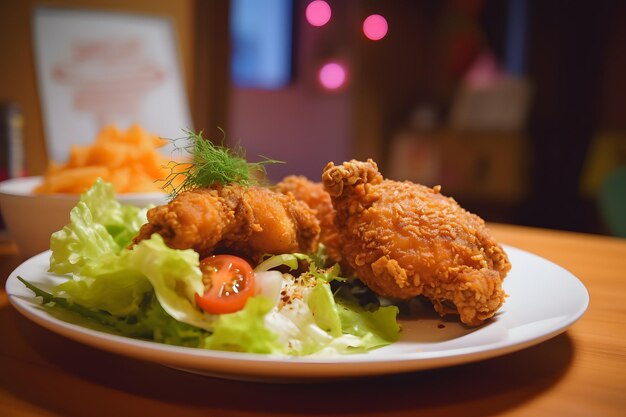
[[0, 0, 626, 236]]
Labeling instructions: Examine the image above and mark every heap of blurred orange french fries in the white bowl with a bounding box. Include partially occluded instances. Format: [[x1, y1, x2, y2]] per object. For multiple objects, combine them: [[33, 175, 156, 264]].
[[35, 124, 183, 194]]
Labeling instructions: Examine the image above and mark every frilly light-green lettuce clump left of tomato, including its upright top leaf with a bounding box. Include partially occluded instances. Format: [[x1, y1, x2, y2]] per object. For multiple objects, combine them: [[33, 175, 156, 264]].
[[50, 179, 210, 328]]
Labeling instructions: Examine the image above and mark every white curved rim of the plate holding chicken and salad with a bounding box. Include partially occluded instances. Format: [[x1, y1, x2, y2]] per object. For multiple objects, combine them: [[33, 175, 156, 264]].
[[5, 245, 590, 380]]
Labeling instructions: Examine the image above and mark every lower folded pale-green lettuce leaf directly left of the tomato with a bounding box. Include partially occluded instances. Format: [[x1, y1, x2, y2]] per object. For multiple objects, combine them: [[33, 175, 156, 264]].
[[55, 234, 205, 329]]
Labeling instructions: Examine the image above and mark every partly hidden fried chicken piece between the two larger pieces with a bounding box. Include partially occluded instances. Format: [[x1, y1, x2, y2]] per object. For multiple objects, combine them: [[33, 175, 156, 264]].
[[274, 175, 346, 264]]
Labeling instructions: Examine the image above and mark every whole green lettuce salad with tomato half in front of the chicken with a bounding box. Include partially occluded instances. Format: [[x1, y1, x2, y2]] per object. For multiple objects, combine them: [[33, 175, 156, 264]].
[[19, 180, 400, 356]]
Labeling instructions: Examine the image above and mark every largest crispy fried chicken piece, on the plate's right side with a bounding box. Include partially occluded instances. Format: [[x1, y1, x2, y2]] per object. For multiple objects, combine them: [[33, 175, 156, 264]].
[[322, 159, 511, 326]]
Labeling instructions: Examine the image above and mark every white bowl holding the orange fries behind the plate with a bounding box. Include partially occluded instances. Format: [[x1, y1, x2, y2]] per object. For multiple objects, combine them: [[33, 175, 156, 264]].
[[0, 177, 168, 258]]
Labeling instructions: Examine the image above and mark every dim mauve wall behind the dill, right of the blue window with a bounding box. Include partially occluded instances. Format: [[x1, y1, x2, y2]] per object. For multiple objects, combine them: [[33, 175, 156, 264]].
[[227, 1, 352, 181]]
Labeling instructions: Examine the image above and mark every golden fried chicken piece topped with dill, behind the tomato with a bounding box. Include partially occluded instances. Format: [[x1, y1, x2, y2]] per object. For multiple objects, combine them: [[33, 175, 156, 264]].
[[133, 184, 320, 260]]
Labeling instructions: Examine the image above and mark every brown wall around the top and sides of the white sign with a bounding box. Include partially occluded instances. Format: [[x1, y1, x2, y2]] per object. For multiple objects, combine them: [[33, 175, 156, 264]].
[[0, 0, 195, 175]]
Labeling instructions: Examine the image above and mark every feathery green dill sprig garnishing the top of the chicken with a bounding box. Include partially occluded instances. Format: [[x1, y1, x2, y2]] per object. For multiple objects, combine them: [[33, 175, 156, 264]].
[[163, 129, 282, 197]]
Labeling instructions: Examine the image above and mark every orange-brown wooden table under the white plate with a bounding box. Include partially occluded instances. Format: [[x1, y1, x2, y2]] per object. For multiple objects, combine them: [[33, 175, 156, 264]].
[[0, 225, 626, 417]]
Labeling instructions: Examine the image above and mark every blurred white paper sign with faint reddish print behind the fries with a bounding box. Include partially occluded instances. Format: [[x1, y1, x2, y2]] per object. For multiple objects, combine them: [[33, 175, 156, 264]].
[[34, 7, 192, 162]]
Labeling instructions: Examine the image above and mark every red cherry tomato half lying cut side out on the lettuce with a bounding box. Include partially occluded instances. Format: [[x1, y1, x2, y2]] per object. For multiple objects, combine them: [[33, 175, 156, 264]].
[[196, 255, 254, 314]]
